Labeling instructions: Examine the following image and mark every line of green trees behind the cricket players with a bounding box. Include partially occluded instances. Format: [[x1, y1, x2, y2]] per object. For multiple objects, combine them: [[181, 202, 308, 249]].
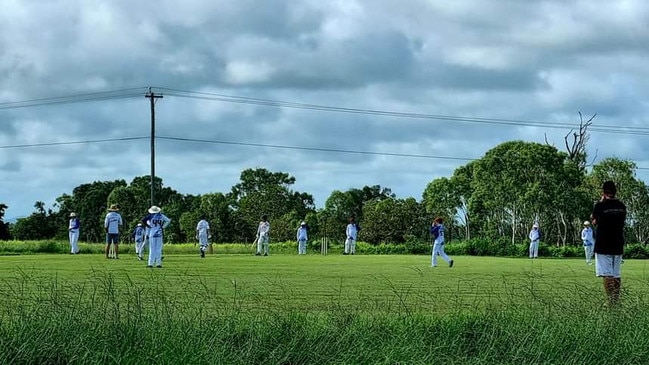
[[0, 141, 649, 246]]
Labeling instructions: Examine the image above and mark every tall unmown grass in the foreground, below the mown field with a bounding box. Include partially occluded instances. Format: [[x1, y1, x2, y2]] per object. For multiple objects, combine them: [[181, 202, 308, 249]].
[[0, 273, 649, 364]]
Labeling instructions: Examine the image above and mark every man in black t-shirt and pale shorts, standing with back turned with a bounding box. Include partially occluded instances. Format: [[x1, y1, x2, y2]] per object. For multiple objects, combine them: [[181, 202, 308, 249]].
[[591, 181, 626, 305]]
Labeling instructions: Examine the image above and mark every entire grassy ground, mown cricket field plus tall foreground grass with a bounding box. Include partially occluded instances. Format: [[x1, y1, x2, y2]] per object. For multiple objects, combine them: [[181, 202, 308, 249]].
[[0, 254, 649, 364]]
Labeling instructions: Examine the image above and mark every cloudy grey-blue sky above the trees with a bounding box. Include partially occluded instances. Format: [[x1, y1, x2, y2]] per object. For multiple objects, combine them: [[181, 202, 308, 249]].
[[0, 0, 649, 220]]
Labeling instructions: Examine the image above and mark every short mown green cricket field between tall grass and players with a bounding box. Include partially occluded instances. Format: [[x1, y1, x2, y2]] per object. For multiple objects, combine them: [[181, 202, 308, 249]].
[[0, 254, 649, 313]]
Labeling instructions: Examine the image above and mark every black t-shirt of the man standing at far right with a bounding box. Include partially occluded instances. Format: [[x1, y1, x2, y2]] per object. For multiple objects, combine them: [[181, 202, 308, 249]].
[[593, 199, 626, 255]]
